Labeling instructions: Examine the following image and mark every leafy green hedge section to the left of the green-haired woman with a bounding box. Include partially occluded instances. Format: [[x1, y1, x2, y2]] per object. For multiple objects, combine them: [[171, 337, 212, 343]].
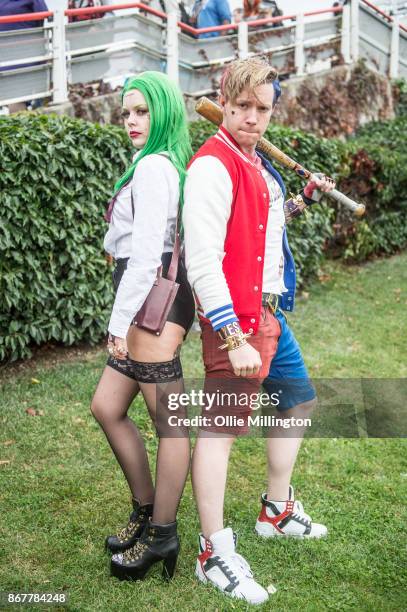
[[0, 114, 130, 360]]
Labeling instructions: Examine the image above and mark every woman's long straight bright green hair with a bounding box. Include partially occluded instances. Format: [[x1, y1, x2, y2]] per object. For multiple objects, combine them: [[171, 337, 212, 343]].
[[114, 71, 192, 205]]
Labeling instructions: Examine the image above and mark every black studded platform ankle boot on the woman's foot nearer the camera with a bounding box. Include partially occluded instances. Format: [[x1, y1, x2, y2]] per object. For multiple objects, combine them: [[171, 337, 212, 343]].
[[110, 522, 180, 580]]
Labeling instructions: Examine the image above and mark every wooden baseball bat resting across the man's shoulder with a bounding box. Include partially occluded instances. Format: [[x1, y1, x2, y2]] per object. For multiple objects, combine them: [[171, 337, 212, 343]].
[[195, 96, 365, 217]]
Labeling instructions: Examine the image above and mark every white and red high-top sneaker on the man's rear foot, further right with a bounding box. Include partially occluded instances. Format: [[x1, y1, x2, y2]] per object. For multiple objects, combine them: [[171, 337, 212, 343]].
[[255, 485, 328, 538]]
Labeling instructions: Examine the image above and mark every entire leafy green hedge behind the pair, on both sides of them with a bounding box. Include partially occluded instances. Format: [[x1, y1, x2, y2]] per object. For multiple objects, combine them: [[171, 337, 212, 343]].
[[0, 113, 407, 361]]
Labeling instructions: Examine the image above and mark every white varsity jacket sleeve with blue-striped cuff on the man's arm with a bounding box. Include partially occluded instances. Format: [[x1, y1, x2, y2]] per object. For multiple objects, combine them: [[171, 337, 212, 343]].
[[183, 155, 238, 330]]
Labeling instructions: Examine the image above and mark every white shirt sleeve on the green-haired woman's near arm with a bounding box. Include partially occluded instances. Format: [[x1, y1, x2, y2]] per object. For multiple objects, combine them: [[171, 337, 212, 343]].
[[109, 155, 178, 338]]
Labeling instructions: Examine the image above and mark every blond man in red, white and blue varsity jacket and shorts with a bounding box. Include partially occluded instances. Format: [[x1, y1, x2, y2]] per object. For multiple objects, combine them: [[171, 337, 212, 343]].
[[183, 58, 334, 604]]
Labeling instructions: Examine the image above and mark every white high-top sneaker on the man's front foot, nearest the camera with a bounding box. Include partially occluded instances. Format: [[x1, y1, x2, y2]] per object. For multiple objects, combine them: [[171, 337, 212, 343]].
[[195, 527, 268, 604]]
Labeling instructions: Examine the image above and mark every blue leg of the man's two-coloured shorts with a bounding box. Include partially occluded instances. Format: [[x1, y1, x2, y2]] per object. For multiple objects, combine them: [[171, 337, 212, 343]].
[[263, 309, 316, 411]]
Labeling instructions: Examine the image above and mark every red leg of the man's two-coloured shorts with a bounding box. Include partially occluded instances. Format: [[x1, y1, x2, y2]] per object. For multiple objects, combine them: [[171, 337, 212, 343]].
[[200, 307, 281, 435]]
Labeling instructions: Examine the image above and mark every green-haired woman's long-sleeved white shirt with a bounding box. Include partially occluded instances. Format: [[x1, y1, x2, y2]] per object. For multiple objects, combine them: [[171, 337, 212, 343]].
[[104, 154, 179, 338]]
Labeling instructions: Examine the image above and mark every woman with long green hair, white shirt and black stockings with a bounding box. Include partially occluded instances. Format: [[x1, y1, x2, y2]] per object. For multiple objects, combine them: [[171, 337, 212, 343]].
[[91, 72, 194, 580]]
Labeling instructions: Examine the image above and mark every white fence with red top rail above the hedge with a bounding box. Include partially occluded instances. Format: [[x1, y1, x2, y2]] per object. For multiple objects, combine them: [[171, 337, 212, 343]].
[[0, 0, 407, 105]]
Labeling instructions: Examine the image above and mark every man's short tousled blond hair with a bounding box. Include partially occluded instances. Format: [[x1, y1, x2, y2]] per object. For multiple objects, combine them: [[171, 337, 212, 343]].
[[220, 57, 278, 101]]
